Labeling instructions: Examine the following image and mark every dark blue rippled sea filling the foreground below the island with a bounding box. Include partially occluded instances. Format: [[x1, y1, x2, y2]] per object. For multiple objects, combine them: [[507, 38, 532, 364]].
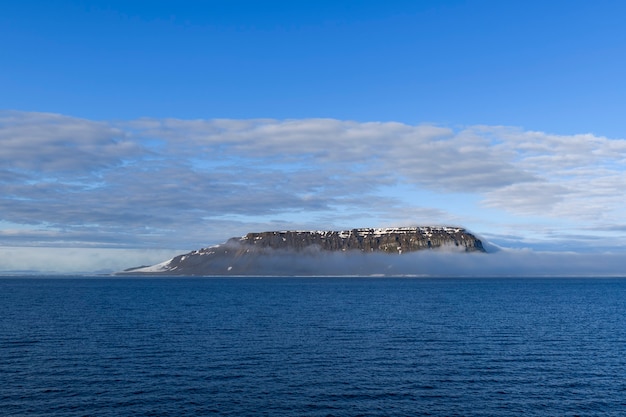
[[0, 277, 626, 416]]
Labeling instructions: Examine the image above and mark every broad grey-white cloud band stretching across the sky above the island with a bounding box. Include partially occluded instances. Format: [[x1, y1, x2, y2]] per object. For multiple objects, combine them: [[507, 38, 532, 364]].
[[0, 111, 626, 272]]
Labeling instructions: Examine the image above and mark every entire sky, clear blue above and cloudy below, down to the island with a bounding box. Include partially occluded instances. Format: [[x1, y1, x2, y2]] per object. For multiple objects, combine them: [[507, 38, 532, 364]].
[[0, 1, 626, 272]]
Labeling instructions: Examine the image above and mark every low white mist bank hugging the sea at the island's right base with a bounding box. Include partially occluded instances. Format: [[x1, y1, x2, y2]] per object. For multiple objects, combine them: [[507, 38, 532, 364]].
[[223, 247, 626, 277]]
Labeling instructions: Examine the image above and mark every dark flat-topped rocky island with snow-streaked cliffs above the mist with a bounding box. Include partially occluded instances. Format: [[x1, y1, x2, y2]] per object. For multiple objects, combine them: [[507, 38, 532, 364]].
[[123, 227, 485, 275]]
